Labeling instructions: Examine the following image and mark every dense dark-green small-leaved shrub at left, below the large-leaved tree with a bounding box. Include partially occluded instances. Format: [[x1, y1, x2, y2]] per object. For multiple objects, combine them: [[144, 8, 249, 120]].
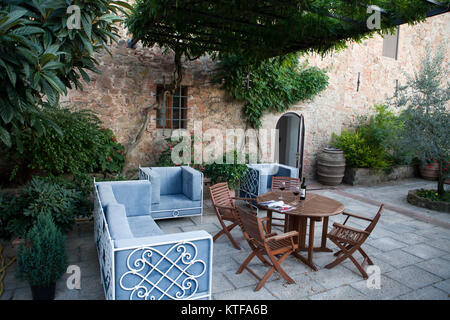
[[9, 108, 125, 177]]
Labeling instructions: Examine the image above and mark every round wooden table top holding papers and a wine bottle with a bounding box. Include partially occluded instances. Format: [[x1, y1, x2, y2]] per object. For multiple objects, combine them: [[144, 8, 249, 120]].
[[256, 191, 344, 217]]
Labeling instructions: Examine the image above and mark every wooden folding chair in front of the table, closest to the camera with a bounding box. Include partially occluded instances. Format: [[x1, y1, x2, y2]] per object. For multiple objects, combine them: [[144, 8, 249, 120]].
[[236, 208, 298, 291]]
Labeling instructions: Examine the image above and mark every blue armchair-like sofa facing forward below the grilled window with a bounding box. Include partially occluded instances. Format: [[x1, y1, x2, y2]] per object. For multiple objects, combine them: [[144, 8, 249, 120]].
[[139, 166, 203, 219]]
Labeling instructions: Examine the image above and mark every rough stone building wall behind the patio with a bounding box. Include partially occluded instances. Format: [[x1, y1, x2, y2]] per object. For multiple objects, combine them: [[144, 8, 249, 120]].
[[64, 13, 450, 177]]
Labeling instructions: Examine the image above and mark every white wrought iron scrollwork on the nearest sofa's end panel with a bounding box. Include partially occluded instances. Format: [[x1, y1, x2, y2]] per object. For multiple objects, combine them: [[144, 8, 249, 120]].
[[120, 242, 207, 300]]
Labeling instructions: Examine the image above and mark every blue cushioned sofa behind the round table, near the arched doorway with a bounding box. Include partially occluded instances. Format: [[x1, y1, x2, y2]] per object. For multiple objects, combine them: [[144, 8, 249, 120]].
[[239, 163, 298, 198]]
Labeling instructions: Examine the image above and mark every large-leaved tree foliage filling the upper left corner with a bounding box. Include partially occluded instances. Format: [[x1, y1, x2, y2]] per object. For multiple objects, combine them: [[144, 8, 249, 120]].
[[0, 0, 129, 152]]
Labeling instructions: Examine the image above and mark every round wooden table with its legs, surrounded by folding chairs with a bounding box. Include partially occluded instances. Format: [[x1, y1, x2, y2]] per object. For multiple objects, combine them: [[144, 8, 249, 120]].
[[256, 191, 344, 271]]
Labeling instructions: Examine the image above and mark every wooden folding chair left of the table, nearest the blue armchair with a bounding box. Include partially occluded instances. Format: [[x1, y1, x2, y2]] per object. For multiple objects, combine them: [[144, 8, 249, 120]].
[[209, 182, 256, 250]]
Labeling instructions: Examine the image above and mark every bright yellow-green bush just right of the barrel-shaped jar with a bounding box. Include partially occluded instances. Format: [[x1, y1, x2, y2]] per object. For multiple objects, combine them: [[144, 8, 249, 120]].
[[332, 131, 391, 169]]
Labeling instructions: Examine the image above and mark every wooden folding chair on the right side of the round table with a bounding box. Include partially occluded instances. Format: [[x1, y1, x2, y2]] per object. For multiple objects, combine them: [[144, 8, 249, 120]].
[[325, 204, 384, 279]]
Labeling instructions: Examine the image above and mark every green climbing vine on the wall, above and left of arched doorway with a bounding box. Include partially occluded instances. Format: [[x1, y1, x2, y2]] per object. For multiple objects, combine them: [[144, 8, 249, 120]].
[[215, 54, 328, 128]]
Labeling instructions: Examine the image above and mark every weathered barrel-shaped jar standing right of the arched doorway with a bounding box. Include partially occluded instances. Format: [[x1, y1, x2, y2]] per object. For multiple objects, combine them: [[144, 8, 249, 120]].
[[317, 148, 345, 186]]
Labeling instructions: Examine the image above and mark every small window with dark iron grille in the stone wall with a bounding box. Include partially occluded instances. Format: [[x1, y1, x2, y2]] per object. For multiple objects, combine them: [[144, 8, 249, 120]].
[[156, 85, 188, 129]]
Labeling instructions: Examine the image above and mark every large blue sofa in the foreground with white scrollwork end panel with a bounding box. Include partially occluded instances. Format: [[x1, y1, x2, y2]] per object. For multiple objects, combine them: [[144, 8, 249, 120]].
[[94, 180, 213, 300]]
